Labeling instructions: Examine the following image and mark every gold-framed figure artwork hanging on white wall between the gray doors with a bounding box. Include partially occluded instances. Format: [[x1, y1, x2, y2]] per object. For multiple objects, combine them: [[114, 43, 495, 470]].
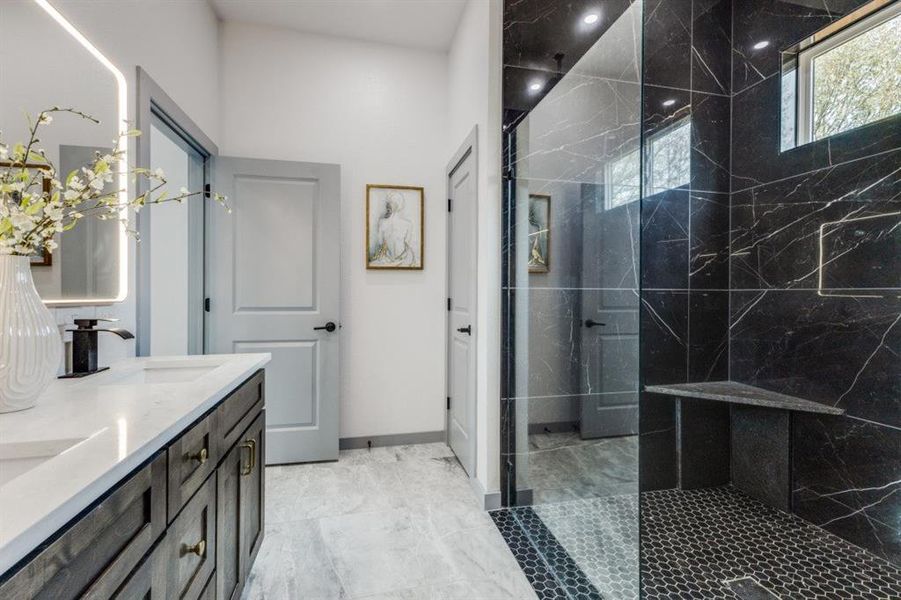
[[366, 184, 425, 270]]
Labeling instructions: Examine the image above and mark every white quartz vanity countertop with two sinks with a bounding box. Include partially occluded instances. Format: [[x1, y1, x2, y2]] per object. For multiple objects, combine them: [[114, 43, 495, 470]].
[[0, 354, 271, 574]]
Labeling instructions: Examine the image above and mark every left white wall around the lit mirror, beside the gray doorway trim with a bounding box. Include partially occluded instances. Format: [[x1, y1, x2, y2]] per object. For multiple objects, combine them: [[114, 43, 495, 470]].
[[48, 0, 219, 364]]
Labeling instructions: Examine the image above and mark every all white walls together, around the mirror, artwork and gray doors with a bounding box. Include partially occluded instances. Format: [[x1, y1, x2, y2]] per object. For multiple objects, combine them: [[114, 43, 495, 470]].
[[35, 0, 501, 491]]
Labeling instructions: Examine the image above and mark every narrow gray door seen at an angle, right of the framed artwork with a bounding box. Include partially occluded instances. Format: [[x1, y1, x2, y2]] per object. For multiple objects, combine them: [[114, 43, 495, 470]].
[[447, 144, 476, 475]]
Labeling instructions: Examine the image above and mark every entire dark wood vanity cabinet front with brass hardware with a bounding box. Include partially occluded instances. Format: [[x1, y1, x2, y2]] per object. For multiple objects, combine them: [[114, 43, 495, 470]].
[[0, 370, 266, 600]]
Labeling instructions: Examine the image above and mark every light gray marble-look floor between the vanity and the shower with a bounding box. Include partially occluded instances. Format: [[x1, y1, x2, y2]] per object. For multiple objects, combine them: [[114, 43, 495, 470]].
[[244, 444, 535, 600]]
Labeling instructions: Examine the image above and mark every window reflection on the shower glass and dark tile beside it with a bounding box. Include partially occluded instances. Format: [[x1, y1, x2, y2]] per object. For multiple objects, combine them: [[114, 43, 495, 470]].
[[605, 118, 691, 210]]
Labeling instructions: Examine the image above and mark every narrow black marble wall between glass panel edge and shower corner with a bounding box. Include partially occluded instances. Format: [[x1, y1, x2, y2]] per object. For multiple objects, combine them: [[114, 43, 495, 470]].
[[639, 0, 731, 491]]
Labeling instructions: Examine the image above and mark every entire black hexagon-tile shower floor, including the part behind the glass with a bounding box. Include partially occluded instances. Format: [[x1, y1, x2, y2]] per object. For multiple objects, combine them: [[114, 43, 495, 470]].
[[491, 486, 901, 600]]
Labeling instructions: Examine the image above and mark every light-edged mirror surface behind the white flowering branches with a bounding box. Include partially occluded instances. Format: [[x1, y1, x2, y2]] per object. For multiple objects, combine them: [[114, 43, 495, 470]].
[[0, 0, 127, 305]]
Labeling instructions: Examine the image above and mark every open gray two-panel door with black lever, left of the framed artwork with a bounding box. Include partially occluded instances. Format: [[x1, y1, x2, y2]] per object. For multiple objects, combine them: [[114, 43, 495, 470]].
[[206, 157, 340, 464]]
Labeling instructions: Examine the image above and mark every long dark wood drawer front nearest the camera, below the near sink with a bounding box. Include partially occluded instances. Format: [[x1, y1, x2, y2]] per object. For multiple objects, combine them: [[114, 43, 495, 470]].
[[0, 452, 166, 600]]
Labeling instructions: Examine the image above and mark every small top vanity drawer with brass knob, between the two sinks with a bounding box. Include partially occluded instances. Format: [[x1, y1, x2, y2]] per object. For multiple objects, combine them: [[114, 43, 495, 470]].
[[168, 411, 219, 523]]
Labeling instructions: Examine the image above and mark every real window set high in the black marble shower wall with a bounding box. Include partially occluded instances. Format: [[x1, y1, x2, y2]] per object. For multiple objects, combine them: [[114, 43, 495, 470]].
[[782, 0, 901, 150]]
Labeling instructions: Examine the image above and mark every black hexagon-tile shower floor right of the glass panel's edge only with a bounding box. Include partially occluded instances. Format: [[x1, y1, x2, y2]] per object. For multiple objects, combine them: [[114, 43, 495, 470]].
[[641, 486, 901, 600]]
